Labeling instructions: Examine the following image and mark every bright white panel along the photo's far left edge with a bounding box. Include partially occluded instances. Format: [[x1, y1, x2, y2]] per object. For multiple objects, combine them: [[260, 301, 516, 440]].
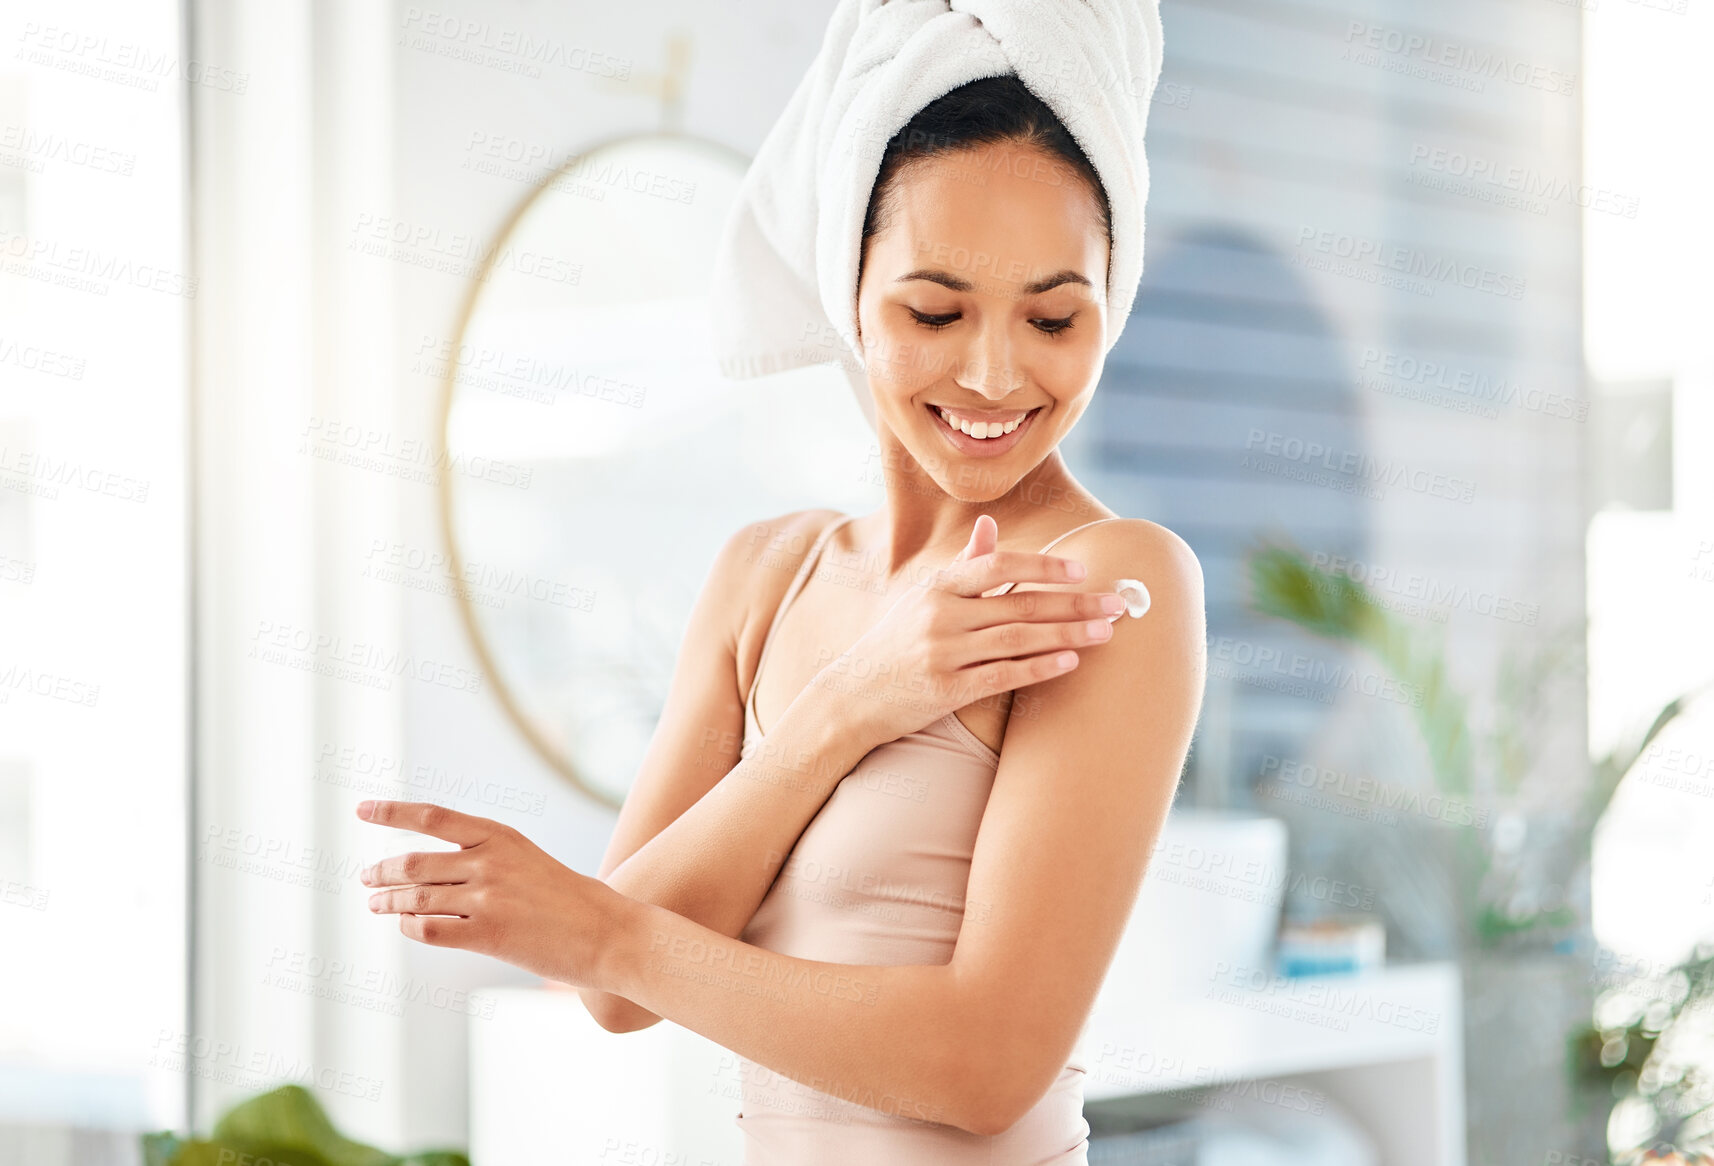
[[0, 0, 197, 1138]]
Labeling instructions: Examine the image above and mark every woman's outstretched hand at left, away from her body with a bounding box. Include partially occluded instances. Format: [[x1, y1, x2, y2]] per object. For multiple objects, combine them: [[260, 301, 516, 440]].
[[357, 801, 629, 988]]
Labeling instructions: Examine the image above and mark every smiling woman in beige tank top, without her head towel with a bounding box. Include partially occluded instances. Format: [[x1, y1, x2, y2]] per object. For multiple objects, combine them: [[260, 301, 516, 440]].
[[360, 77, 1205, 1166]]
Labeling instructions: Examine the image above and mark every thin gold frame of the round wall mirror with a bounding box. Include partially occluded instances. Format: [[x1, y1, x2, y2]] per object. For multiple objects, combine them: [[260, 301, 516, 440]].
[[439, 130, 751, 811]]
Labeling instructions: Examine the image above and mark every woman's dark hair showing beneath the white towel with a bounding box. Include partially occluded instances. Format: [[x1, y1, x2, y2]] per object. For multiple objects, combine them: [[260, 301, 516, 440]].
[[857, 74, 1112, 281]]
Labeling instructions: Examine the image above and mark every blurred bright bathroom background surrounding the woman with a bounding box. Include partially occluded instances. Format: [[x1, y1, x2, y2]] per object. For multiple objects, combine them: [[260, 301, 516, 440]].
[[0, 0, 1714, 1166]]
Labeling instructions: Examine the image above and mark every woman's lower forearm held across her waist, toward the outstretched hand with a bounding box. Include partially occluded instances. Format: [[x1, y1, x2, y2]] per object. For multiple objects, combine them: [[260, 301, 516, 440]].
[[600, 904, 992, 1132]]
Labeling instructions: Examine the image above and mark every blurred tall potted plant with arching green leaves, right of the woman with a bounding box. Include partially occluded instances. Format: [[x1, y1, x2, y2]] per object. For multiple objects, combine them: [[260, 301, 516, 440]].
[[1248, 545, 1707, 1166]]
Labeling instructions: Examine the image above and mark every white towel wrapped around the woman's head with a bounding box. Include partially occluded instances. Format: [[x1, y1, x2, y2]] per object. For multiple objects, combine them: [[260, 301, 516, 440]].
[[713, 0, 1160, 425]]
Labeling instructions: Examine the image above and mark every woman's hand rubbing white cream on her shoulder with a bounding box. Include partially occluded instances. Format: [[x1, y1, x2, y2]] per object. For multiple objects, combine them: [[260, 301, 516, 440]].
[[809, 514, 1124, 748]]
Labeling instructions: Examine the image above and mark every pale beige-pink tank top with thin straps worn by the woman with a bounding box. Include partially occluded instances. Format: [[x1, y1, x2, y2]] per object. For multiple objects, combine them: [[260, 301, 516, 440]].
[[735, 514, 1114, 1166]]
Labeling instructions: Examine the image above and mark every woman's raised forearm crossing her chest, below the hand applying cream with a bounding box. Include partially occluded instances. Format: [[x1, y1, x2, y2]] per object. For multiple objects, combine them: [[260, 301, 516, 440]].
[[579, 686, 869, 1032]]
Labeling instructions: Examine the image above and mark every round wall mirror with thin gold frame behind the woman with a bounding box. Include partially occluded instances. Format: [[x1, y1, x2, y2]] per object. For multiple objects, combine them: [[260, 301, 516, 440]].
[[440, 134, 883, 808]]
